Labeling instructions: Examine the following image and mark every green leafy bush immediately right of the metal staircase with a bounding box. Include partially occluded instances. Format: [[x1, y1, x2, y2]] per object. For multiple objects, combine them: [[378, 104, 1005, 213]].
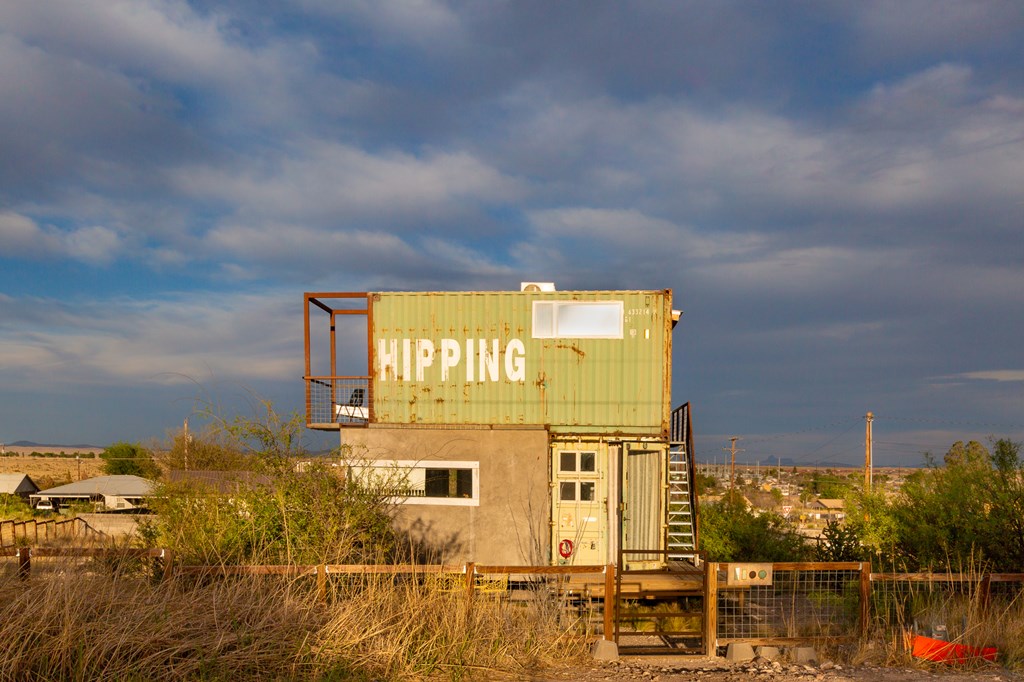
[[698, 495, 810, 561]]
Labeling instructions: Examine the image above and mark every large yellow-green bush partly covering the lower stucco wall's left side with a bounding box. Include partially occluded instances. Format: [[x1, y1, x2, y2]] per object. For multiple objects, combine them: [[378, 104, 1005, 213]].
[[143, 401, 395, 564]]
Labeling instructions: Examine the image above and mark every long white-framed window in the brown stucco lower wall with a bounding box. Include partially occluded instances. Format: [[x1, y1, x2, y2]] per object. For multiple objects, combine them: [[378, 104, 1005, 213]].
[[350, 460, 480, 507]]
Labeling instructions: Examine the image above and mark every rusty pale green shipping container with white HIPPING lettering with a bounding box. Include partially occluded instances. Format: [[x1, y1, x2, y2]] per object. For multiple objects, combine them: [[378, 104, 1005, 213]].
[[370, 290, 673, 435]]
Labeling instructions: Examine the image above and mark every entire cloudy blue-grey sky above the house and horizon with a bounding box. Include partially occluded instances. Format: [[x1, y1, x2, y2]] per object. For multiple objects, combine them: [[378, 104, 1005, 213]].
[[0, 0, 1024, 464]]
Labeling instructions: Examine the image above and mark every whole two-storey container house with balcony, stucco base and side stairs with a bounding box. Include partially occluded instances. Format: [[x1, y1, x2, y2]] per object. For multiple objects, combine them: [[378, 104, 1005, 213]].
[[304, 285, 695, 567]]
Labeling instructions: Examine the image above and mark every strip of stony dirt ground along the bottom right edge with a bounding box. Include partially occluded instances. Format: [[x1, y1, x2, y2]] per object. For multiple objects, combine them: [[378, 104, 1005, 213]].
[[528, 656, 1024, 682]]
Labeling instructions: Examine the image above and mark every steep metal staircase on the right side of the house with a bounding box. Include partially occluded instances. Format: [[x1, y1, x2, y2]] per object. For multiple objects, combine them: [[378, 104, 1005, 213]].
[[667, 402, 697, 561]]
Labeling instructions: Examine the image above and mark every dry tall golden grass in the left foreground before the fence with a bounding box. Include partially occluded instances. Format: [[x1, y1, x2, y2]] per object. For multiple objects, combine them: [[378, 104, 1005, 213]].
[[0, 561, 586, 680]]
